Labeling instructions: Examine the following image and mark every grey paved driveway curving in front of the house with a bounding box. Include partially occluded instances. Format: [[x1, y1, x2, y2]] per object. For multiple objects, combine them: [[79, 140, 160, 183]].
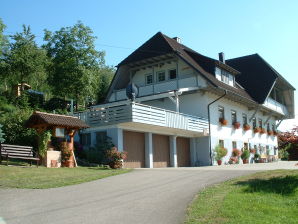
[[0, 163, 295, 224]]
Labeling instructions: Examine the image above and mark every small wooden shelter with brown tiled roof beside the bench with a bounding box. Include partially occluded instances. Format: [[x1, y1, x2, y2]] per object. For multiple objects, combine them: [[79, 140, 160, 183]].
[[25, 111, 89, 166]]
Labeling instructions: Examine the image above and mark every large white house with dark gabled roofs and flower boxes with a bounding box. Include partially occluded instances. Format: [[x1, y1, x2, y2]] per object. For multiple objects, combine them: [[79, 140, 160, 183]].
[[78, 32, 295, 168]]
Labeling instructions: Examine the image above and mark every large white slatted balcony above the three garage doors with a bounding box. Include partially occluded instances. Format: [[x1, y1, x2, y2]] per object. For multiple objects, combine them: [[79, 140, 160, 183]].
[[75, 102, 208, 136]]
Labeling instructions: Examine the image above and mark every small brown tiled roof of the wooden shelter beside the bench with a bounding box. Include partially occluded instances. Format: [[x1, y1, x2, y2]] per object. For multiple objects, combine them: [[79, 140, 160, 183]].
[[25, 111, 89, 129]]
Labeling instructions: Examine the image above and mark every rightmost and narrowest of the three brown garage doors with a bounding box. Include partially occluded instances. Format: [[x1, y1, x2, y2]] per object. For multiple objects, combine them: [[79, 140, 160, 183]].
[[177, 137, 190, 167]]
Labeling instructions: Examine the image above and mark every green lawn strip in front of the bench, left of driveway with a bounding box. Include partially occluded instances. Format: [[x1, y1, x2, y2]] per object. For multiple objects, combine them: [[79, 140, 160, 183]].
[[0, 165, 131, 189]]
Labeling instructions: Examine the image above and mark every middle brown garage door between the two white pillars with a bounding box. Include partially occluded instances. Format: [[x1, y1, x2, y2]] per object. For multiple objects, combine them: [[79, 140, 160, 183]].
[[152, 135, 170, 168]]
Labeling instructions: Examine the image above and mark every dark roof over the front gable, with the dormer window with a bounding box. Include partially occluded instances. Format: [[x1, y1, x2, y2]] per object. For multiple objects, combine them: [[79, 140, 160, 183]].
[[118, 32, 253, 101]]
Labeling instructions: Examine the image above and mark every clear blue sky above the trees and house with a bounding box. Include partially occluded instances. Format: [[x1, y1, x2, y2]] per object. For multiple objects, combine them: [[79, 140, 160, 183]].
[[0, 0, 298, 130]]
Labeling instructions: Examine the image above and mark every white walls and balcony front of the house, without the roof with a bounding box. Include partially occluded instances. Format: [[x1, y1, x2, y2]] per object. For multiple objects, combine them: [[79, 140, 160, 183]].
[[76, 53, 286, 168]]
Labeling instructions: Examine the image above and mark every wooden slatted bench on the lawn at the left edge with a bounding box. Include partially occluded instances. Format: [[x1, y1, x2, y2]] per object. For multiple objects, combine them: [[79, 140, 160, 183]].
[[0, 144, 39, 167]]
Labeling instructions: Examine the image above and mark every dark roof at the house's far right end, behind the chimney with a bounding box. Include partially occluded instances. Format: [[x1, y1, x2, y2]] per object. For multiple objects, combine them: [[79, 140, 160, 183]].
[[226, 54, 295, 104]]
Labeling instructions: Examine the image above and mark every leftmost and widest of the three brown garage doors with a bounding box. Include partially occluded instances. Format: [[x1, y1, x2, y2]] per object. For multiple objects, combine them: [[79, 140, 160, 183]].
[[123, 131, 145, 168]]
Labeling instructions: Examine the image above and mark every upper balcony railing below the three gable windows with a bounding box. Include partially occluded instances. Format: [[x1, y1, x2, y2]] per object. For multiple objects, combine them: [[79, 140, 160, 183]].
[[110, 76, 199, 102]]
